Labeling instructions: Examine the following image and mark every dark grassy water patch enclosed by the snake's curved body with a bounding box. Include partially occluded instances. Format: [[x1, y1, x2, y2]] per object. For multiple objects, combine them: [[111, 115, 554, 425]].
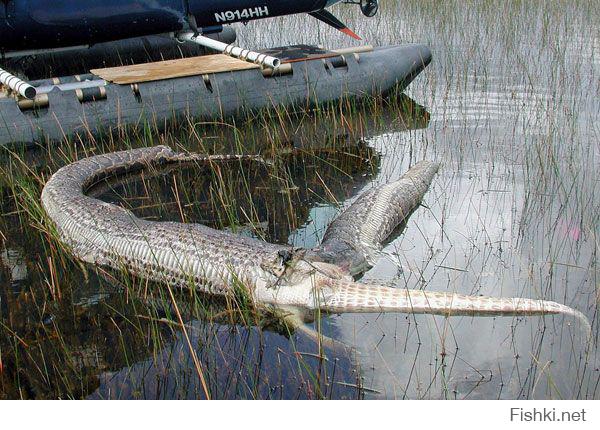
[[90, 140, 378, 243]]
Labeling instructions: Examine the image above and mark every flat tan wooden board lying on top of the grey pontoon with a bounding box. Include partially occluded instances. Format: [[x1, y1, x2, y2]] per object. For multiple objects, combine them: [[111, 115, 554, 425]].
[[90, 54, 259, 85]]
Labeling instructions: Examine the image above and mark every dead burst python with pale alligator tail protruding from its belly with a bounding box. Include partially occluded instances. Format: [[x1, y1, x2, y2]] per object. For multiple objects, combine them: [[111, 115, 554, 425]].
[[42, 146, 587, 330]]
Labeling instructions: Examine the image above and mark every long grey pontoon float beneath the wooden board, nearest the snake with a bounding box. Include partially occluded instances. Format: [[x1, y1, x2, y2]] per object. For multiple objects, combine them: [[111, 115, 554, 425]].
[[0, 45, 431, 145]]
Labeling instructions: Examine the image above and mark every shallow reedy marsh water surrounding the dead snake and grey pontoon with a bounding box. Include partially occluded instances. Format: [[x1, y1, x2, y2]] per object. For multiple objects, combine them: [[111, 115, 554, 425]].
[[0, 0, 600, 399]]
